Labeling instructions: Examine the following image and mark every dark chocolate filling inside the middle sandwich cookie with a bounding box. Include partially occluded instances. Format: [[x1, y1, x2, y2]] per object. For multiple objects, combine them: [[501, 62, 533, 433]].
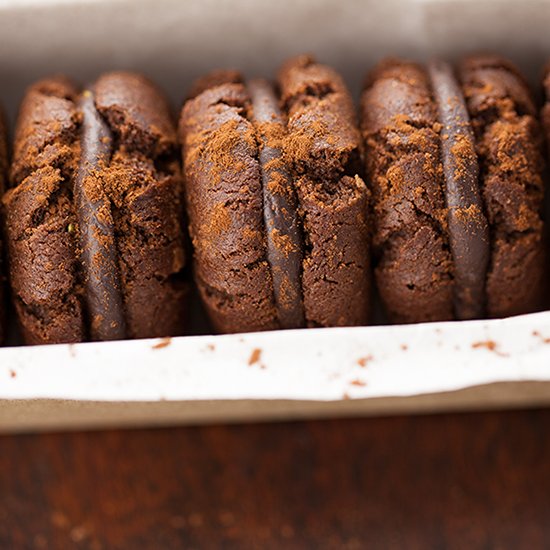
[[248, 79, 305, 328]]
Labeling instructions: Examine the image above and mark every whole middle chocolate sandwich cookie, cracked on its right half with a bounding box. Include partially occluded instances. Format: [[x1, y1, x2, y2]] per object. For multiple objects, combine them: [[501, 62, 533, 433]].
[[180, 56, 369, 332]]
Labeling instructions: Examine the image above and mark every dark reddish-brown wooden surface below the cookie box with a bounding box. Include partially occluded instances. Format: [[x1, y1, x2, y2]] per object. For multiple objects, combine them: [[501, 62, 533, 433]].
[[0, 410, 550, 550]]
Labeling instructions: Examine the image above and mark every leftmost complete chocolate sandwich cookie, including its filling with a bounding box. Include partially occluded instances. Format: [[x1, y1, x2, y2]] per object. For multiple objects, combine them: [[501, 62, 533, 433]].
[[3, 72, 189, 344]]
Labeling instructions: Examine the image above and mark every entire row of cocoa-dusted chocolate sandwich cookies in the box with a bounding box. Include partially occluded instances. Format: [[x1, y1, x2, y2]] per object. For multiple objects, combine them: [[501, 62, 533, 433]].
[[0, 52, 550, 343]]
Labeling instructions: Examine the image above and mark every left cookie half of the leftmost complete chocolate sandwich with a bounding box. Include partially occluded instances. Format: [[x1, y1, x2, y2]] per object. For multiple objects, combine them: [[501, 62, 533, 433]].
[[2, 78, 86, 344]]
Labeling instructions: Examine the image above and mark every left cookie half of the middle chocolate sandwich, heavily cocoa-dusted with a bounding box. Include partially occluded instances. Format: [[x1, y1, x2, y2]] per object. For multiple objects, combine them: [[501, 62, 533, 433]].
[[179, 83, 279, 332]]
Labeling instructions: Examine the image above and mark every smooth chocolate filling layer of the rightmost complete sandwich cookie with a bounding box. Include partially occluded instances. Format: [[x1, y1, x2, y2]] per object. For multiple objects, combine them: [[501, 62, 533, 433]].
[[428, 61, 490, 319]]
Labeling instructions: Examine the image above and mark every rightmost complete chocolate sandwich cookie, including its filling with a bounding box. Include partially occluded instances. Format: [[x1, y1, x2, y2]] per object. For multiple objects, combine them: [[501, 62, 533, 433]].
[[361, 56, 544, 322]]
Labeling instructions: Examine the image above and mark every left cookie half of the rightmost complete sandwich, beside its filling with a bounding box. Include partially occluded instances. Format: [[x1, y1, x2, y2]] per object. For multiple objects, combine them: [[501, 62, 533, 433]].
[[361, 60, 454, 323]]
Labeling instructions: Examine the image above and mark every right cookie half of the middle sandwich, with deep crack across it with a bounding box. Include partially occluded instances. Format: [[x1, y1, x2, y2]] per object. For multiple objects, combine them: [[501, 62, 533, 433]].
[[278, 56, 370, 327]]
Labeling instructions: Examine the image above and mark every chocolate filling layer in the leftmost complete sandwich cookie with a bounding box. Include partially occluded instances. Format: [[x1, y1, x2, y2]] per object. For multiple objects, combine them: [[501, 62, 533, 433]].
[[73, 90, 126, 340]]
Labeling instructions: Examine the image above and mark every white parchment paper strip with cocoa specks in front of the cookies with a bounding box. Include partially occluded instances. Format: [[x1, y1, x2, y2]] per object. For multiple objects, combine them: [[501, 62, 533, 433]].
[[0, 312, 550, 401]]
